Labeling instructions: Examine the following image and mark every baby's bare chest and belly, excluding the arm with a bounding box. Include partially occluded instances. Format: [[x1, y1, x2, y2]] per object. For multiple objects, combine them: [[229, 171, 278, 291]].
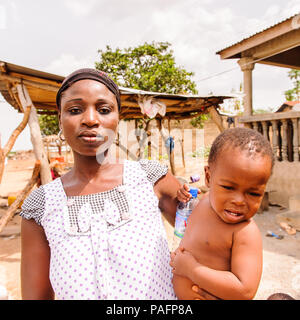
[[173, 197, 247, 300]]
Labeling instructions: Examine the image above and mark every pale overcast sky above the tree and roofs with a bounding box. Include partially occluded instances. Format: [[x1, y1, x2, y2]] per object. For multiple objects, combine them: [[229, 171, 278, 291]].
[[0, 0, 300, 150]]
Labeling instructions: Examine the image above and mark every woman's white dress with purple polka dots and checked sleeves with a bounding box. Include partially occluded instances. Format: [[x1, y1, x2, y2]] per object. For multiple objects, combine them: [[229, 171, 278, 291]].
[[21, 160, 176, 300]]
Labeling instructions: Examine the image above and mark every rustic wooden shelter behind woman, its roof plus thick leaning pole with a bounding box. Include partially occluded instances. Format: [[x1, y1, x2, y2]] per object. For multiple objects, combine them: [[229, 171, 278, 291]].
[[0, 61, 233, 179]]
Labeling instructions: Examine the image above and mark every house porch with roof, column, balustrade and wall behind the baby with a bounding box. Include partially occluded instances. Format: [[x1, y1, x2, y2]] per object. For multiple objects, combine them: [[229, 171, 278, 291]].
[[217, 14, 300, 206]]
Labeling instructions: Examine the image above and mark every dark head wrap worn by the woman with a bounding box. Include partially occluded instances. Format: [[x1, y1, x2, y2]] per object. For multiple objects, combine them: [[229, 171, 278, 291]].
[[56, 68, 121, 111]]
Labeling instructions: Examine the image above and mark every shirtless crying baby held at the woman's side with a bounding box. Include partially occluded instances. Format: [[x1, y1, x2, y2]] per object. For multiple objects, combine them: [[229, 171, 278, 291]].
[[170, 128, 274, 300]]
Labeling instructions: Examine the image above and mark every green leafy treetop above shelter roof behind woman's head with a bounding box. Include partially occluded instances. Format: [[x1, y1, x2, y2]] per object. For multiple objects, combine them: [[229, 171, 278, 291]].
[[95, 42, 197, 94]]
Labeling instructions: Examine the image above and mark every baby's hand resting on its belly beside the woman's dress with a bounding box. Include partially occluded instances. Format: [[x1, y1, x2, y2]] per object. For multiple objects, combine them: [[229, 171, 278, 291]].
[[170, 247, 198, 277]]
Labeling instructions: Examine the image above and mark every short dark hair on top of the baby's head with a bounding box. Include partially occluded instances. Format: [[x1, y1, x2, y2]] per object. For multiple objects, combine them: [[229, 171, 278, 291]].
[[208, 128, 274, 168]]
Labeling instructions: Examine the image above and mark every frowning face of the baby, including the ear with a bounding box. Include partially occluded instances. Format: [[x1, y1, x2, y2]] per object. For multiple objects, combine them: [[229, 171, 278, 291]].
[[205, 148, 272, 223]]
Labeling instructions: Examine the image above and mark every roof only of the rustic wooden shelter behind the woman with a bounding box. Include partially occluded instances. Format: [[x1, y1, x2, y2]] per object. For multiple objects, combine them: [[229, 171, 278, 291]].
[[0, 61, 233, 119]]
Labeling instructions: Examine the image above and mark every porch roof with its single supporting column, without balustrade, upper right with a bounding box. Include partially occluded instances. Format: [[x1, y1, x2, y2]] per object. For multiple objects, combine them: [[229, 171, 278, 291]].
[[217, 14, 300, 116]]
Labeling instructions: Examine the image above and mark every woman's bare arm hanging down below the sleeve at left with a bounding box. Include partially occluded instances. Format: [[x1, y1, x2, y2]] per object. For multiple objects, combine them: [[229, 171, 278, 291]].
[[21, 219, 54, 300]]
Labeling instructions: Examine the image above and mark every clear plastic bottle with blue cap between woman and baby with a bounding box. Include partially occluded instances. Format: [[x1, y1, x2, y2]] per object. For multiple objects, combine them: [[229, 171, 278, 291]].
[[172, 188, 198, 251]]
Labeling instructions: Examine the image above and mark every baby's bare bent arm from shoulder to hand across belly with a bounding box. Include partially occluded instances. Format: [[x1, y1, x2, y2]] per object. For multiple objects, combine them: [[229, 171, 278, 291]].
[[170, 221, 262, 300]]
